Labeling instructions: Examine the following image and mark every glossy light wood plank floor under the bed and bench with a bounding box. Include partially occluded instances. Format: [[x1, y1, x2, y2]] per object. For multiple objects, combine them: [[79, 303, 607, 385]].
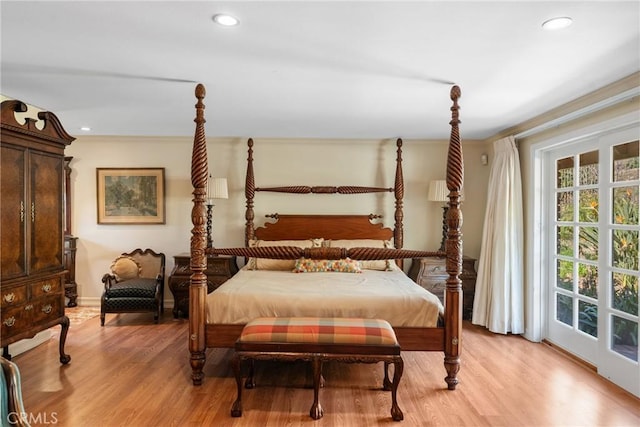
[[13, 312, 640, 427]]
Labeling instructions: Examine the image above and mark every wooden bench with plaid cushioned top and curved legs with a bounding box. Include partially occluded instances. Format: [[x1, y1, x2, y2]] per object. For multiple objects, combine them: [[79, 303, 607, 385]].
[[231, 317, 404, 421]]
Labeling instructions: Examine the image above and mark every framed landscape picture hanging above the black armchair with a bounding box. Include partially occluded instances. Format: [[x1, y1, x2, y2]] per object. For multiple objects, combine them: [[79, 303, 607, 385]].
[[96, 168, 165, 224]]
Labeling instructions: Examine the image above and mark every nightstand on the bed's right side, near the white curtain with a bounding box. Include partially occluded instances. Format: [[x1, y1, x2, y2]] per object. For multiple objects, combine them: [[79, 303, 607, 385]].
[[409, 257, 477, 320]]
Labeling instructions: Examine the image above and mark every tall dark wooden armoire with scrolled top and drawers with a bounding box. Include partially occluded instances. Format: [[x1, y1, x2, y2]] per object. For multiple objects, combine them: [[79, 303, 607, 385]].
[[0, 100, 75, 364]]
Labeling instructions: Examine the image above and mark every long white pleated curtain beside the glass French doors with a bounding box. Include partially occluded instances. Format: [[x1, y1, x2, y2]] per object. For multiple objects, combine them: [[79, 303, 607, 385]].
[[472, 136, 524, 334]]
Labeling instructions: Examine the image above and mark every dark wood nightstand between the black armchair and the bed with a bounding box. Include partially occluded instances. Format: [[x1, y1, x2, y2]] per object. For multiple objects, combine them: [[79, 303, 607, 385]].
[[169, 253, 238, 318]]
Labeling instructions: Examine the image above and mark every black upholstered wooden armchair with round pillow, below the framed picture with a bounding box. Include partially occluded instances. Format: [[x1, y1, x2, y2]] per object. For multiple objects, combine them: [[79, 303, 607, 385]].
[[100, 249, 165, 326]]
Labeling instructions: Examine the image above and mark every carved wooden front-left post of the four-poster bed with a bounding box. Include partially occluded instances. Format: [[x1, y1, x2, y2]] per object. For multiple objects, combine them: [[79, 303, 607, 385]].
[[189, 84, 209, 385]]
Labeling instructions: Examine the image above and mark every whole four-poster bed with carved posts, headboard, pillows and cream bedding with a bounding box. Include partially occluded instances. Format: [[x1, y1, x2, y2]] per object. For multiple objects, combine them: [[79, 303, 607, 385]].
[[189, 85, 463, 390]]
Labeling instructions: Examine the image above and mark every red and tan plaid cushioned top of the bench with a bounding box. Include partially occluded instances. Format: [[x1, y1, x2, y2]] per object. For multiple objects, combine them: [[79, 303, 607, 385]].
[[238, 317, 398, 346]]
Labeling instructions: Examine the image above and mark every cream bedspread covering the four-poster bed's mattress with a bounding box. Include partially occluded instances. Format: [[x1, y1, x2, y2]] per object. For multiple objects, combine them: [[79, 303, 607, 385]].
[[207, 269, 444, 327]]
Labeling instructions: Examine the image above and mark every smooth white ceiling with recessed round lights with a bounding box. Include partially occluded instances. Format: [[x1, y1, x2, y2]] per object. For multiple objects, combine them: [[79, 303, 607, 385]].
[[0, 0, 640, 139]]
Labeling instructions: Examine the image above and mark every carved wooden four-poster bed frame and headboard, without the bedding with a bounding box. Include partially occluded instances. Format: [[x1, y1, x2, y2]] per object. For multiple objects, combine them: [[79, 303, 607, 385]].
[[189, 84, 463, 390]]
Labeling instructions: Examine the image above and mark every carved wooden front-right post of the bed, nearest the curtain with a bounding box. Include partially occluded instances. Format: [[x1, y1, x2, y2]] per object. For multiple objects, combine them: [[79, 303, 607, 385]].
[[444, 86, 464, 390]]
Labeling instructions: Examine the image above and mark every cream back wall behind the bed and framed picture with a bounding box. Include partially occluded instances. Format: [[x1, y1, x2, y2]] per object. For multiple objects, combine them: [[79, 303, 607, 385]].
[[63, 135, 491, 307]]
